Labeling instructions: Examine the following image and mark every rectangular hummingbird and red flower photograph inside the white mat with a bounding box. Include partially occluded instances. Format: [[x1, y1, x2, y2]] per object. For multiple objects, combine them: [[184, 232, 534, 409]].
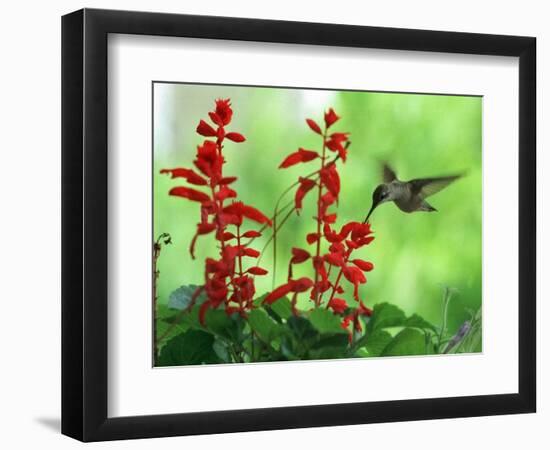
[[152, 81, 483, 367]]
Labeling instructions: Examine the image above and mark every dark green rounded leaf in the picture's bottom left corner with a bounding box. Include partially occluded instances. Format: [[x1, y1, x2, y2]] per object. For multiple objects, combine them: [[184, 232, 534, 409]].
[[157, 330, 221, 366]]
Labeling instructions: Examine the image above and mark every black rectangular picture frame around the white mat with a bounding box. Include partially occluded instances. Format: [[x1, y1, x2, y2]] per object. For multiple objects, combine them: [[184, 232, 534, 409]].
[[62, 9, 536, 441]]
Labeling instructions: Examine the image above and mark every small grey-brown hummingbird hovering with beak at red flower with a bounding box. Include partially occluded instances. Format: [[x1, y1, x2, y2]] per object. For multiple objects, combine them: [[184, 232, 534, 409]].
[[364, 164, 462, 223]]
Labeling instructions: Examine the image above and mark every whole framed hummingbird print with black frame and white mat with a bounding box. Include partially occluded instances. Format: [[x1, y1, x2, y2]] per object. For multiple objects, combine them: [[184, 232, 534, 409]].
[[62, 9, 536, 441]]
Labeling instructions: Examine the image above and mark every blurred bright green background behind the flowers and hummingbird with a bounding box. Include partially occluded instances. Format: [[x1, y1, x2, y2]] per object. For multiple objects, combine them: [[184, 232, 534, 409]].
[[153, 83, 482, 332]]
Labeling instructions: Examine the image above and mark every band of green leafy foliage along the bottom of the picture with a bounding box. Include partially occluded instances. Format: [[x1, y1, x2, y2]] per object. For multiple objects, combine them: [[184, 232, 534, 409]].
[[157, 288, 474, 366]]
